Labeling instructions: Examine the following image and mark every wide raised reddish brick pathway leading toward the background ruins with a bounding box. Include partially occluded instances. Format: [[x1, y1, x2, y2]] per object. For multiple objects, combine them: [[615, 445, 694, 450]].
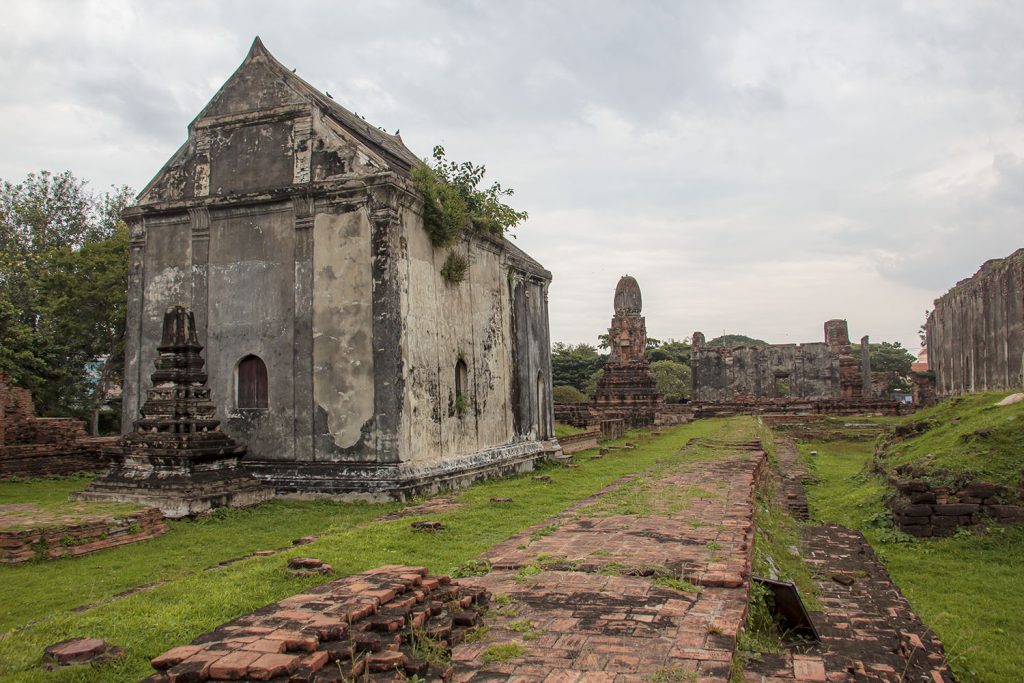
[[453, 441, 765, 682]]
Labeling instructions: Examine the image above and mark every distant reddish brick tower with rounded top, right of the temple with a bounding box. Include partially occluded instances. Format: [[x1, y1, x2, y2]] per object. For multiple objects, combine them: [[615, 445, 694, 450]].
[[594, 275, 662, 427]]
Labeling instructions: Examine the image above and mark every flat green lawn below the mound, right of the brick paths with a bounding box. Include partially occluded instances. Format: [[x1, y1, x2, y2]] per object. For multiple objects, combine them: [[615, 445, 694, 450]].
[[800, 438, 1024, 683]]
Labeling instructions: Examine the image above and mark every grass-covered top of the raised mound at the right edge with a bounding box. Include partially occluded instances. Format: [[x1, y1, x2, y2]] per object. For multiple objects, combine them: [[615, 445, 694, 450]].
[[882, 392, 1024, 490]]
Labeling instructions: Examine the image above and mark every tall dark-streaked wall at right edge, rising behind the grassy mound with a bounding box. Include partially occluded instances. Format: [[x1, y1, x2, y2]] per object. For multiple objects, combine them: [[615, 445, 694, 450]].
[[926, 249, 1024, 396]]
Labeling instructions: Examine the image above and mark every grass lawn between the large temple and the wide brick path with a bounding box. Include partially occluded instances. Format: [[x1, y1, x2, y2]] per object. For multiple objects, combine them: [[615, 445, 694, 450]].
[[0, 418, 751, 682]]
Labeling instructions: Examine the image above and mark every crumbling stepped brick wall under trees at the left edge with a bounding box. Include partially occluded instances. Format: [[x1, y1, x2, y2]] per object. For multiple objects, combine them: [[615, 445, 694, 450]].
[[0, 373, 117, 477]]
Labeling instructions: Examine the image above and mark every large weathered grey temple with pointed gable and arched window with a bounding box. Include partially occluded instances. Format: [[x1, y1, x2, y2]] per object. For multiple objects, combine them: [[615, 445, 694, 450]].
[[124, 39, 557, 497]]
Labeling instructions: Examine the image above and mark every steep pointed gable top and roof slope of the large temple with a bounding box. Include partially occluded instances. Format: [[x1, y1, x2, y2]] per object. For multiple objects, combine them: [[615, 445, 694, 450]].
[[189, 36, 420, 172]]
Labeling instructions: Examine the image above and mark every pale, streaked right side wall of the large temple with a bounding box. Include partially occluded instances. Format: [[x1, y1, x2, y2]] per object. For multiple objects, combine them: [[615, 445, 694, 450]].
[[401, 204, 550, 466]]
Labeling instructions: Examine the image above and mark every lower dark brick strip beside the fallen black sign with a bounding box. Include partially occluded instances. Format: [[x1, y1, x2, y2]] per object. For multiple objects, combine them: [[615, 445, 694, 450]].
[[745, 526, 955, 683]]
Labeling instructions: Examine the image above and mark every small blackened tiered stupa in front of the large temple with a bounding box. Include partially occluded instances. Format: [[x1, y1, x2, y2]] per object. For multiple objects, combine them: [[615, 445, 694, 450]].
[[74, 306, 273, 517]]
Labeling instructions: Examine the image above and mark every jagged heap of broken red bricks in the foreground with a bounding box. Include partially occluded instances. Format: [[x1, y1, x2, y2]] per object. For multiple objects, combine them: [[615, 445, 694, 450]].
[[145, 565, 490, 683]]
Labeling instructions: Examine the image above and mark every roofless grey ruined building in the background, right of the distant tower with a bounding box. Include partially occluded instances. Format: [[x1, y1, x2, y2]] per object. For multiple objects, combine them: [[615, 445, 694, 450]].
[[690, 319, 871, 402]]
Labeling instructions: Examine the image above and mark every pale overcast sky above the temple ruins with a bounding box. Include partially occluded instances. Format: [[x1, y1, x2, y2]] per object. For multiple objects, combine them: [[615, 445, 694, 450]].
[[0, 0, 1024, 351]]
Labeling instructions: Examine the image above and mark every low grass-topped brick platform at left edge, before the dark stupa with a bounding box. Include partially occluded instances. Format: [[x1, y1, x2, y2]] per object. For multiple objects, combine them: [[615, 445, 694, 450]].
[[0, 503, 167, 564]]
